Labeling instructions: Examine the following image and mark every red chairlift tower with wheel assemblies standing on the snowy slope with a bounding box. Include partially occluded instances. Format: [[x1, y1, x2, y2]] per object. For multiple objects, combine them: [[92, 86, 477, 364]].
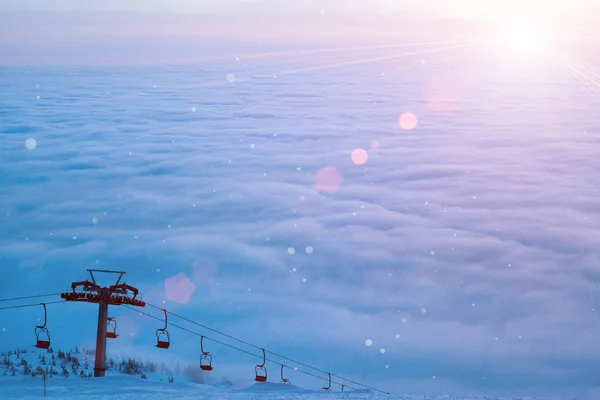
[[60, 269, 146, 377]]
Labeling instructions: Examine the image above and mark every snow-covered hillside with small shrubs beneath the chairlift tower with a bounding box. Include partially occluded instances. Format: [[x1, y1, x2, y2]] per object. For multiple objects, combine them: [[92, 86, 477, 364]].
[[0, 348, 389, 400]]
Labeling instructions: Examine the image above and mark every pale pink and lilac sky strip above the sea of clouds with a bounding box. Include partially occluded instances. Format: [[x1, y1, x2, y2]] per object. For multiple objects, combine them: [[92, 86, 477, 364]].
[[0, 0, 600, 65]]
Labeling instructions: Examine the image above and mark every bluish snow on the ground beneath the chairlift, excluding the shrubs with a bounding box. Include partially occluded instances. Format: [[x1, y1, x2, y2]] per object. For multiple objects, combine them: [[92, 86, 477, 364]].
[[0, 349, 389, 400]]
